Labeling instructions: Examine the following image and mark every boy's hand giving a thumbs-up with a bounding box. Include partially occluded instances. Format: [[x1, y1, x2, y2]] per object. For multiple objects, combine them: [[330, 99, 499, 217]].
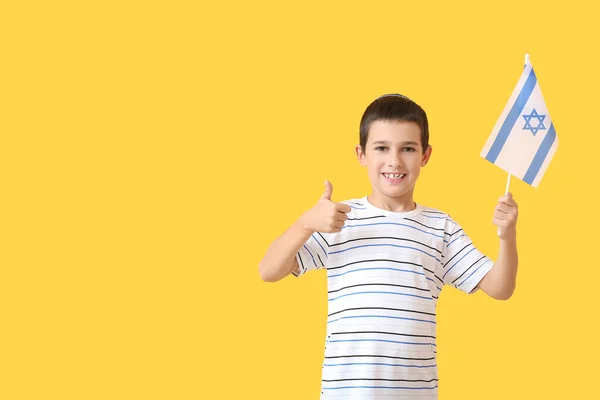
[[301, 181, 350, 233]]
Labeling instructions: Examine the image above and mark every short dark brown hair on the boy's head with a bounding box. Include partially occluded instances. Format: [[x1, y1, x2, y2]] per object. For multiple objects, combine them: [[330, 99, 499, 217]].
[[360, 93, 429, 152]]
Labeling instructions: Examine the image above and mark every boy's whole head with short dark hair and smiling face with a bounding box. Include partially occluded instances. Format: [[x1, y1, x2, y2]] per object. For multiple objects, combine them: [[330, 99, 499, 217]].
[[356, 94, 431, 203]]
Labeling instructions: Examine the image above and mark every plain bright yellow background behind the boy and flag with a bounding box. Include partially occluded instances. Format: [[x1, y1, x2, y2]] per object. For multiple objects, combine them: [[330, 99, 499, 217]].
[[0, 0, 600, 400]]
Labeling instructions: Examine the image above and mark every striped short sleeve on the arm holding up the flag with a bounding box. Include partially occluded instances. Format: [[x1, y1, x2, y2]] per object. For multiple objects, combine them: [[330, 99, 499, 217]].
[[441, 217, 494, 294]]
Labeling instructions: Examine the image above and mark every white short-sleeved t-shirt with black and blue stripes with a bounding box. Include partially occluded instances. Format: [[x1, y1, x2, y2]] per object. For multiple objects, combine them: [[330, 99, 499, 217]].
[[293, 196, 493, 400]]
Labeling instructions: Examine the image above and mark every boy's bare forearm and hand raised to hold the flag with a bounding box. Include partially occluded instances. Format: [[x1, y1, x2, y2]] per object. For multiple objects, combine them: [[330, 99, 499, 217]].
[[478, 193, 519, 300]]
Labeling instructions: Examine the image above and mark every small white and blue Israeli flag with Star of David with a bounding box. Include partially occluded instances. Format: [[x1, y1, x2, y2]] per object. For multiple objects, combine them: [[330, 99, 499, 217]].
[[481, 55, 558, 188]]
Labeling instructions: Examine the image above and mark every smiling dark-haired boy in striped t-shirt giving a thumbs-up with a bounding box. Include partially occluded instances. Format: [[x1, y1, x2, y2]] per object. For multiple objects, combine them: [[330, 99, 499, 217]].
[[259, 94, 518, 399]]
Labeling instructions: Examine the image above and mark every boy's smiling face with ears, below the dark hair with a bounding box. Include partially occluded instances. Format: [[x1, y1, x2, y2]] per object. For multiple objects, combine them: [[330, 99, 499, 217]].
[[356, 121, 431, 205]]
